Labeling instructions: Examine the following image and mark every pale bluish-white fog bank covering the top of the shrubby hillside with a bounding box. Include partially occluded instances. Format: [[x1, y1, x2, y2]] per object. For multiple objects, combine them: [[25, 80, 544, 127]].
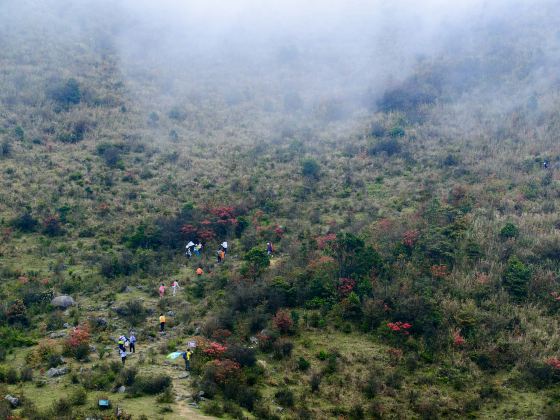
[[0, 0, 560, 126]]
